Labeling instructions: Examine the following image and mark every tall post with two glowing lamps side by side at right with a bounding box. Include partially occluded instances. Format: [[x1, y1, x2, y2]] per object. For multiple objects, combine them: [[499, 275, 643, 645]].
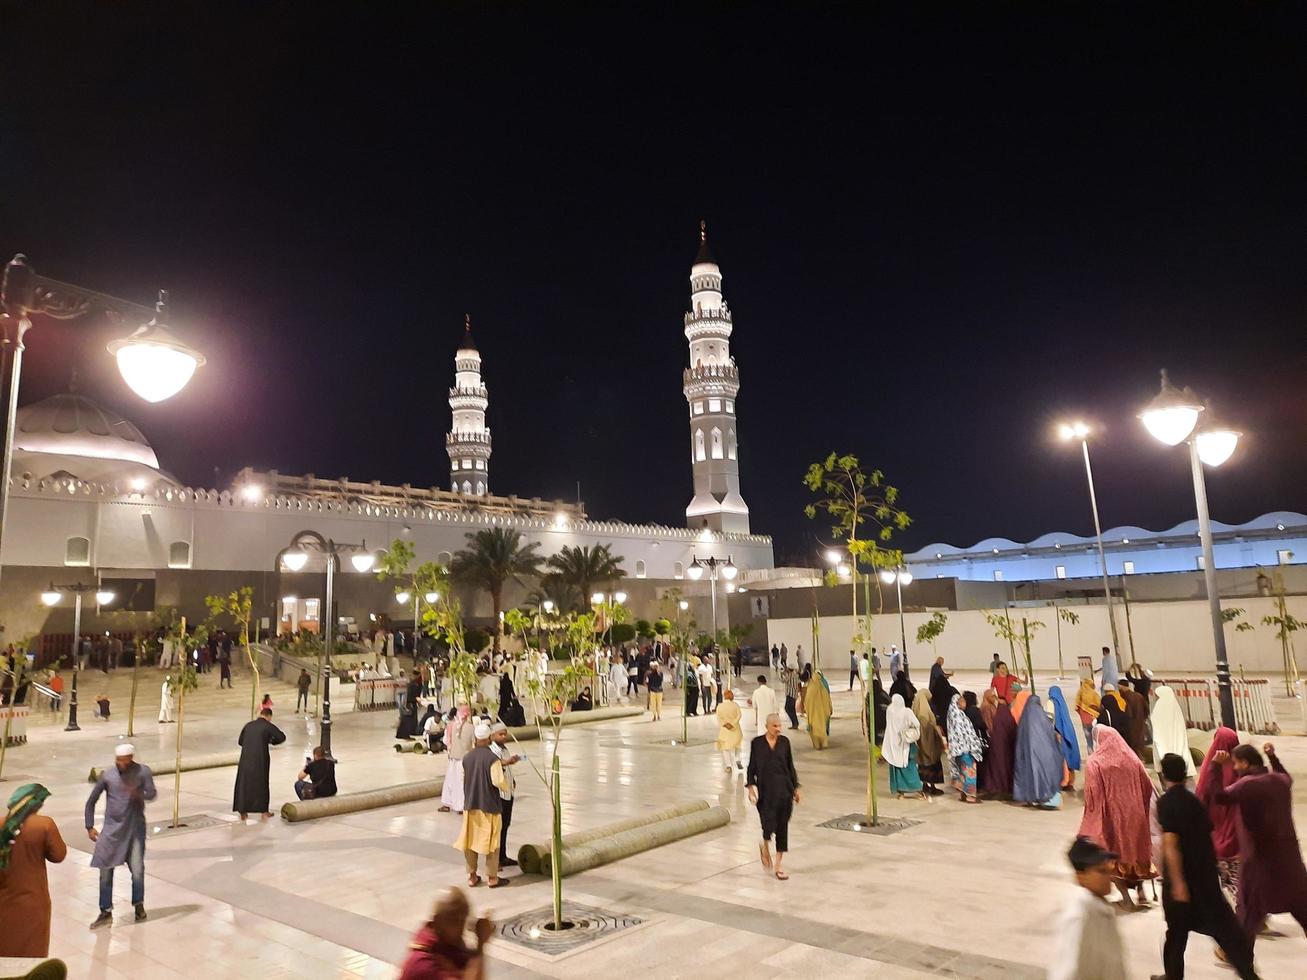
[[1140, 370, 1242, 729]]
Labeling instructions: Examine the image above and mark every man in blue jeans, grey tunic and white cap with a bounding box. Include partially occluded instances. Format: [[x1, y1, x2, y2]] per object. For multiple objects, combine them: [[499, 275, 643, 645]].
[[86, 742, 158, 929]]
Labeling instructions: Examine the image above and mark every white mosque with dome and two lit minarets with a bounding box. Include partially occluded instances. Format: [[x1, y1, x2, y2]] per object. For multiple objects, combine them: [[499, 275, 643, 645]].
[[0, 229, 774, 642]]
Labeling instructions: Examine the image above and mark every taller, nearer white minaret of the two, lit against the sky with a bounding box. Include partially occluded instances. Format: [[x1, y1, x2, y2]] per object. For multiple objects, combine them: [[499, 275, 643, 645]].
[[684, 221, 749, 533]]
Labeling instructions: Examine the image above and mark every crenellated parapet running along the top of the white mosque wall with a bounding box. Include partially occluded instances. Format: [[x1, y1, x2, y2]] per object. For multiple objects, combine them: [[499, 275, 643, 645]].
[[9, 468, 771, 545]]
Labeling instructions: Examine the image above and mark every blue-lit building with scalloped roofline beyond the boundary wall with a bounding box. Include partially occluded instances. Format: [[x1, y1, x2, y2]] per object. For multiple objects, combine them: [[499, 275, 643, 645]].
[[904, 511, 1307, 581]]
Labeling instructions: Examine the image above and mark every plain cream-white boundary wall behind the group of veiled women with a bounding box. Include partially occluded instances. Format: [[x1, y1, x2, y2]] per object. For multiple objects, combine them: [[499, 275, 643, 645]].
[[767, 596, 1307, 677]]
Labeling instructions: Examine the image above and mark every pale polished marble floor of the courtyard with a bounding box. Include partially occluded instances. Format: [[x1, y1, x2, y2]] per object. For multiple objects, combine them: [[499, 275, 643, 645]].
[[4, 670, 1307, 980]]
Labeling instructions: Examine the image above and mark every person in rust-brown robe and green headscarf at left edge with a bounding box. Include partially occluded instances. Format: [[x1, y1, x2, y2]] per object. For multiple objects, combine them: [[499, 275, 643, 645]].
[[0, 783, 68, 956]]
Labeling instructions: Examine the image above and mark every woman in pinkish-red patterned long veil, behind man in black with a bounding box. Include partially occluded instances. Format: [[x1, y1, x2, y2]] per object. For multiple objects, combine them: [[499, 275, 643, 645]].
[[1078, 726, 1157, 908]]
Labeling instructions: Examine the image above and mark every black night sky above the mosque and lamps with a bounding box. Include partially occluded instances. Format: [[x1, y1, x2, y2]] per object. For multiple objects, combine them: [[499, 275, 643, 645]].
[[0, 3, 1307, 559]]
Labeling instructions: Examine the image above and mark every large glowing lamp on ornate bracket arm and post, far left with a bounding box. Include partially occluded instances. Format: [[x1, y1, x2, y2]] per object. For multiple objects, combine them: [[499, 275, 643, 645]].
[[0, 255, 204, 590]]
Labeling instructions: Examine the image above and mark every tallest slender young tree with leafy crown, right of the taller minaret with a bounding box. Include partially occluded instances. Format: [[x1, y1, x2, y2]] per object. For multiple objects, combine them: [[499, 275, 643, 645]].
[[804, 452, 912, 827]]
